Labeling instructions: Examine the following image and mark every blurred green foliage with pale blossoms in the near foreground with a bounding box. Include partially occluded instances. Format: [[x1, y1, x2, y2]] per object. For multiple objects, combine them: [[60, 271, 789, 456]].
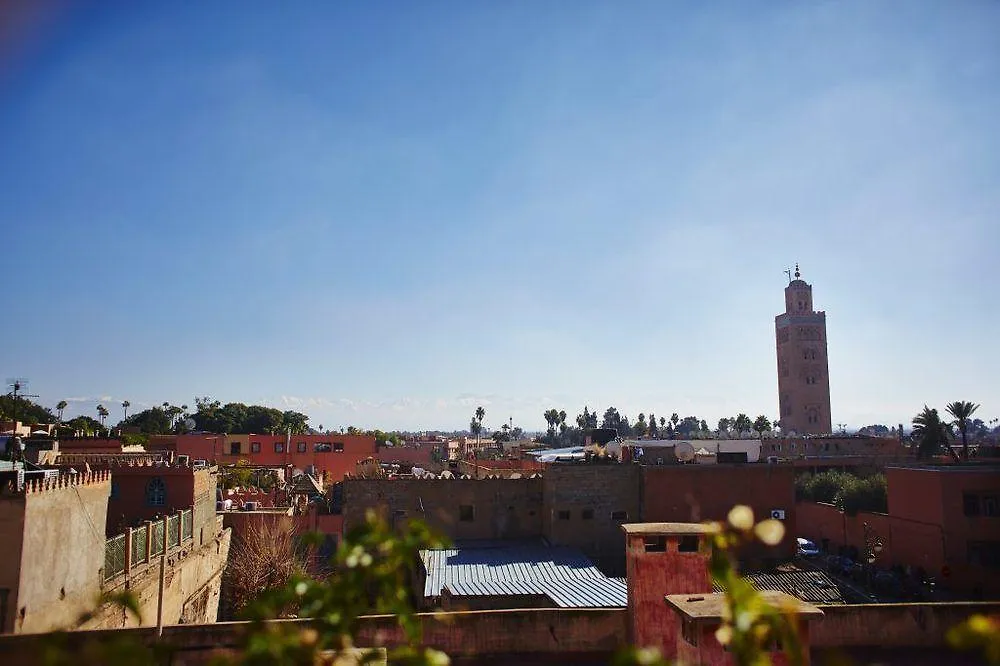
[[42, 506, 1000, 666]]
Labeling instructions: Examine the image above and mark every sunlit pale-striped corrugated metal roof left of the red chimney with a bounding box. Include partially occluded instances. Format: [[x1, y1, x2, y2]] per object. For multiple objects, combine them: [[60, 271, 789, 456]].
[[420, 544, 627, 608]]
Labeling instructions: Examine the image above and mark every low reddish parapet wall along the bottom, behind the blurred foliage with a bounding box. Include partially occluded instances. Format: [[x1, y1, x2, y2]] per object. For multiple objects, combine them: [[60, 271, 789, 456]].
[[0, 602, 1000, 666]]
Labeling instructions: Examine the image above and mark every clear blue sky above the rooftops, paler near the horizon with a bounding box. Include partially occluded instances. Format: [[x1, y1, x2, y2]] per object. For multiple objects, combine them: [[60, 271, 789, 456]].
[[0, 0, 1000, 429]]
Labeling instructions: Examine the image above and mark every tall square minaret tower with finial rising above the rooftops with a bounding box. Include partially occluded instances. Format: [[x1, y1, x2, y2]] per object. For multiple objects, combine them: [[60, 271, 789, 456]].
[[774, 264, 833, 435]]
